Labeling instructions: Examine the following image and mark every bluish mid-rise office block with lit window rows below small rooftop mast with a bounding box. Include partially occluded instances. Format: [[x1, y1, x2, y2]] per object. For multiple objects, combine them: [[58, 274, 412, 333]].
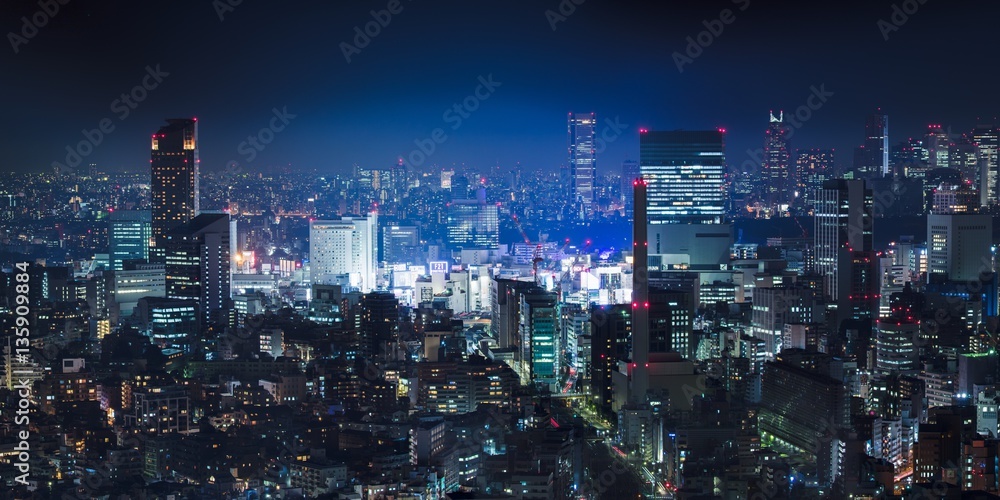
[[447, 195, 500, 250]]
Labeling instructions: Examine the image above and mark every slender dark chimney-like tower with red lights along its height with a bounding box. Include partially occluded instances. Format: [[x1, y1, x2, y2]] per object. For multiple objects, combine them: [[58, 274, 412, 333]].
[[632, 177, 649, 398]]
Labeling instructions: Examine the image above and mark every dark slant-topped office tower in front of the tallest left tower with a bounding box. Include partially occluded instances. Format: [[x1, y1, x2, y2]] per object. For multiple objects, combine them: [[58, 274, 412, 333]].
[[162, 214, 232, 324]]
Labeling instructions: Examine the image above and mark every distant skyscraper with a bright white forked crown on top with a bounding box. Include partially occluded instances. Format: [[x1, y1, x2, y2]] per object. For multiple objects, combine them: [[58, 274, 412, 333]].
[[759, 111, 798, 211]]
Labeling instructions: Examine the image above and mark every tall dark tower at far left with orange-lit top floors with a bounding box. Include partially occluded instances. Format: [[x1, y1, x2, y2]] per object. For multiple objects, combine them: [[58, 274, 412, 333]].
[[150, 118, 200, 262]]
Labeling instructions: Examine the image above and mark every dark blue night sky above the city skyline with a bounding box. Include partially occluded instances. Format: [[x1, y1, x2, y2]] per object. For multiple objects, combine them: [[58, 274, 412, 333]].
[[0, 0, 1000, 176]]
